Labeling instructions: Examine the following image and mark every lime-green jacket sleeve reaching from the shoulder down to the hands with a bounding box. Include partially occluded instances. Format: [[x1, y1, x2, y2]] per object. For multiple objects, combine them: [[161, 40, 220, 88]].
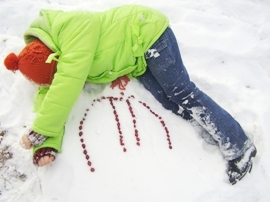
[[32, 13, 99, 150]]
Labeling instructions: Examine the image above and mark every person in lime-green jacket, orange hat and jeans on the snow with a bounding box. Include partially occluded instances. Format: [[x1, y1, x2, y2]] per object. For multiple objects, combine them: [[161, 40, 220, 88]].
[[4, 5, 256, 184]]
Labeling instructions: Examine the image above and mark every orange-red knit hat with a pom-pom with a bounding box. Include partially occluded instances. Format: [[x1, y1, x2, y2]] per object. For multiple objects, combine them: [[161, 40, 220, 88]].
[[4, 40, 56, 85]]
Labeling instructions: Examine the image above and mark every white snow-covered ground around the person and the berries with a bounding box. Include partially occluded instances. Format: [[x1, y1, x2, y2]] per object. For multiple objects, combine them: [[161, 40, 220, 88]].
[[0, 0, 270, 202]]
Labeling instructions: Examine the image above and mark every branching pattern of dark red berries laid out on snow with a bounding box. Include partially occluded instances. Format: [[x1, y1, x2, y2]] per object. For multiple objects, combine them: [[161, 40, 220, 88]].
[[79, 92, 172, 172]]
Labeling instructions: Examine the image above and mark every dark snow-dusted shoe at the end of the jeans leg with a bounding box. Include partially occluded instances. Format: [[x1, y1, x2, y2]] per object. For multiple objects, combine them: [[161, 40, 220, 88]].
[[227, 146, 257, 185]]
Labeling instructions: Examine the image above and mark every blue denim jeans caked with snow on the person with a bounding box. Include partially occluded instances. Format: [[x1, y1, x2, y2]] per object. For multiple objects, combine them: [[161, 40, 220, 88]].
[[138, 28, 253, 160]]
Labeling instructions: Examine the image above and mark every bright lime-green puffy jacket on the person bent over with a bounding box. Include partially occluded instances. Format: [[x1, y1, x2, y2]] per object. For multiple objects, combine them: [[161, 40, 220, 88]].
[[24, 5, 169, 151]]
